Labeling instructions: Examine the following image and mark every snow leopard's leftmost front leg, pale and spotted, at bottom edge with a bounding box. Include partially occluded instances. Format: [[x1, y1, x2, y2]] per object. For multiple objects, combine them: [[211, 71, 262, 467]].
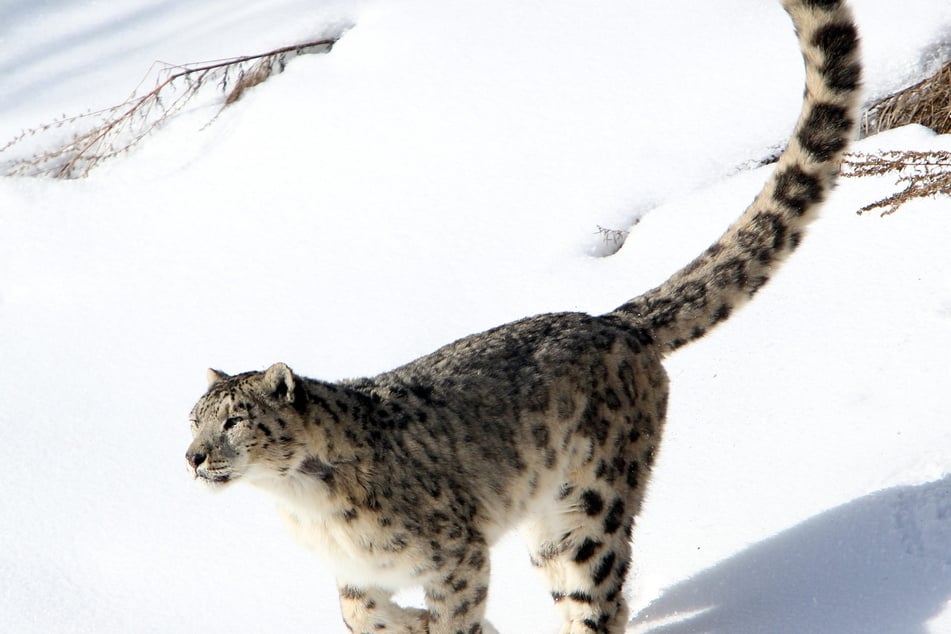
[[339, 584, 429, 634]]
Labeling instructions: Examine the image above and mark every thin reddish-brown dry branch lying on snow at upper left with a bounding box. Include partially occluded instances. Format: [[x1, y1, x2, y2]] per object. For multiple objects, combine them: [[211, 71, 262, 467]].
[[0, 38, 337, 178]]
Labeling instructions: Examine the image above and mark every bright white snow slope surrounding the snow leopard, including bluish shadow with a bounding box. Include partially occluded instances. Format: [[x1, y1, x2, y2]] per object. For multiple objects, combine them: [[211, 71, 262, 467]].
[[0, 0, 951, 634]]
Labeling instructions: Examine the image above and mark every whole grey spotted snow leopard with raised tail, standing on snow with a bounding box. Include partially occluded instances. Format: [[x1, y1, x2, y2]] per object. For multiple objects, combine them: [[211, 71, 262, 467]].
[[186, 0, 861, 634]]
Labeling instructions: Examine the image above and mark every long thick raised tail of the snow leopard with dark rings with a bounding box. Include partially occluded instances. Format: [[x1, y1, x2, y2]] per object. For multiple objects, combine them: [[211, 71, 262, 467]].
[[610, 0, 862, 352]]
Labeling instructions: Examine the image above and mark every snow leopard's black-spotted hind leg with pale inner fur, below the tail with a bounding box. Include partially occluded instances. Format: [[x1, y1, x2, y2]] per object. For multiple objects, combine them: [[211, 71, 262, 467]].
[[520, 372, 667, 634]]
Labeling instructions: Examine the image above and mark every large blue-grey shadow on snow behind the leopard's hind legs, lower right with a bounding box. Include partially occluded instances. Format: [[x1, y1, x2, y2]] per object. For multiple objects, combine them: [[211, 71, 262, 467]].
[[629, 475, 951, 634]]
